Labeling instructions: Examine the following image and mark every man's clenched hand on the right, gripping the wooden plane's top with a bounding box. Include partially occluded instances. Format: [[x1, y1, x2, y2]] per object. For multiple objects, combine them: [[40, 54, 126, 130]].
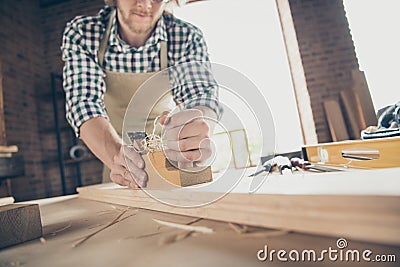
[[160, 109, 216, 162]]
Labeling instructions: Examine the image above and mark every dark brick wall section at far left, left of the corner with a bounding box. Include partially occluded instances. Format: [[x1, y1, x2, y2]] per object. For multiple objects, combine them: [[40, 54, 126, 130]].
[[0, 1, 48, 200]]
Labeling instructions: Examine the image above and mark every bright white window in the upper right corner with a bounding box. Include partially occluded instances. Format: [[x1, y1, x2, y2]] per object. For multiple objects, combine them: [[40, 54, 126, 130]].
[[343, 0, 400, 110]]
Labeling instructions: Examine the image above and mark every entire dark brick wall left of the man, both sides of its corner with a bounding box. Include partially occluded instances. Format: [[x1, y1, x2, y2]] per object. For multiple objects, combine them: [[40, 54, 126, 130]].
[[0, 0, 103, 200]]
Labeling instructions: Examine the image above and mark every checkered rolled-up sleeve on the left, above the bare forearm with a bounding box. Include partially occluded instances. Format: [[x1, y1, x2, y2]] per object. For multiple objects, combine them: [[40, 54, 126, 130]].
[[61, 21, 108, 137]]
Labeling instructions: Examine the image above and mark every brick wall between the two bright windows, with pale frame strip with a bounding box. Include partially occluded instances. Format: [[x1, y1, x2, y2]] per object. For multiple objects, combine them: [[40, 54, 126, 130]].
[[277, 0, 358, 143]]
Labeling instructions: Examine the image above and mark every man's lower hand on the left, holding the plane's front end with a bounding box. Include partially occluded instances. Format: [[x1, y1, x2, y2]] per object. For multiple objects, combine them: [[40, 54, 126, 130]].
[[110, 145, 148, 189]]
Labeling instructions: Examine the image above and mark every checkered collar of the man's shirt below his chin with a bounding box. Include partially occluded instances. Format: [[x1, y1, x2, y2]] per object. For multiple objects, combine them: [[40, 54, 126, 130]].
[[110, 11, 168, 52]]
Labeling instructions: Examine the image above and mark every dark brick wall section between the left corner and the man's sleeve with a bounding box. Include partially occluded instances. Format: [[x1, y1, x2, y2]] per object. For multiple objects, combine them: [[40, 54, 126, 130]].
[[39, 0, 104, 197]]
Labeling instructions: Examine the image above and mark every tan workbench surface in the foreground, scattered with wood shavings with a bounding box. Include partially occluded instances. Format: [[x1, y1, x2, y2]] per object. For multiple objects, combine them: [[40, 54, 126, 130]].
[[0, 196, 400, 267]]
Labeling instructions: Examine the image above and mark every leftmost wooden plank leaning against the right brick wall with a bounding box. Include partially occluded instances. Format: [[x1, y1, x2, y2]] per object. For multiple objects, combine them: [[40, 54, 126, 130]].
[[324, 100, 349, 142]]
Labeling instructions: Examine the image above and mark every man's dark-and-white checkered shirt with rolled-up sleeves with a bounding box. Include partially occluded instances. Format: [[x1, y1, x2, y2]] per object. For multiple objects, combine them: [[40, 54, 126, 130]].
[[61, 7, 222, 136]]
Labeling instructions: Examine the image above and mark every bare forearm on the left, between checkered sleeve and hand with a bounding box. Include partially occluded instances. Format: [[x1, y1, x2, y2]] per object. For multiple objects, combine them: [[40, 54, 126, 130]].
[[80, 117, 122, 168]]
